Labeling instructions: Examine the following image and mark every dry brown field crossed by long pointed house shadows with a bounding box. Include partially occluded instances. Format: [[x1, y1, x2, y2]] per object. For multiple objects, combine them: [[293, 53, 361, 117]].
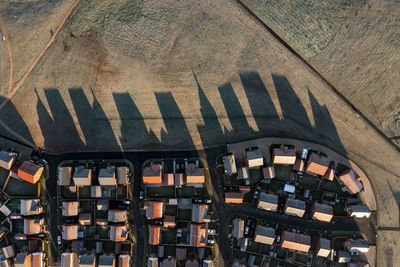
[[0, 0, 400, 264]]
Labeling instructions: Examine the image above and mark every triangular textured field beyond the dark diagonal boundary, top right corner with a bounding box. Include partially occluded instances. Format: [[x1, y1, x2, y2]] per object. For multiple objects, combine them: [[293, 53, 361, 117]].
[[241, 0, 400, 145]]
